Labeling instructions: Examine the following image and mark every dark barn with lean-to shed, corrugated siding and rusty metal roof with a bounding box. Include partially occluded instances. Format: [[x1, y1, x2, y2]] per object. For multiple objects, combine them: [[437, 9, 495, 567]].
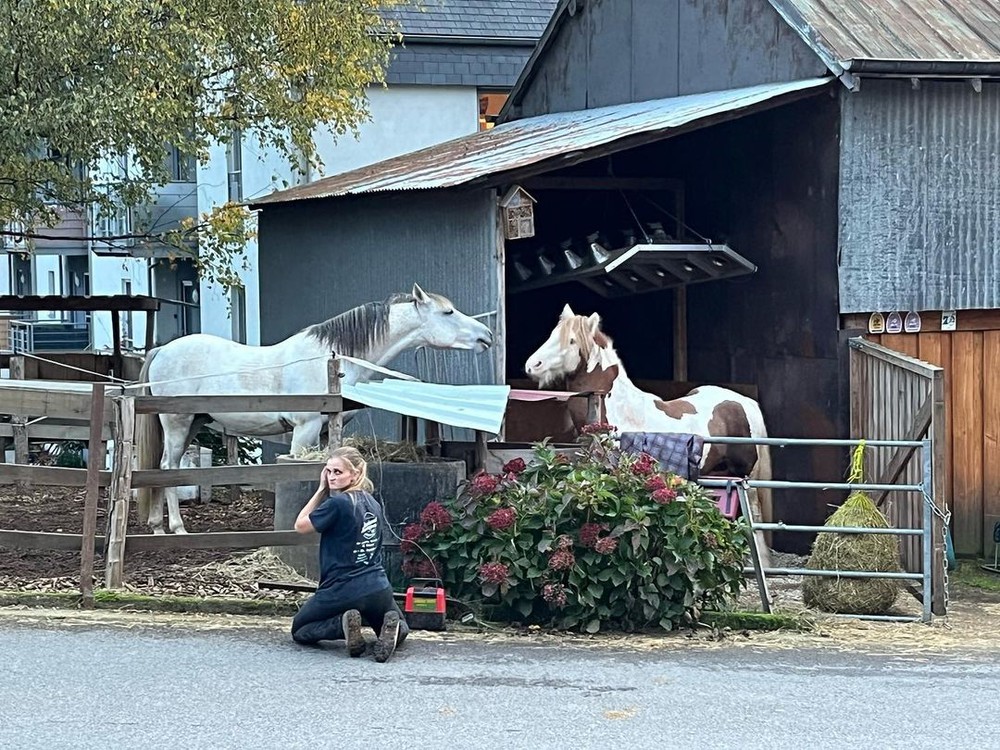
[[253, 0, 1000, 554]]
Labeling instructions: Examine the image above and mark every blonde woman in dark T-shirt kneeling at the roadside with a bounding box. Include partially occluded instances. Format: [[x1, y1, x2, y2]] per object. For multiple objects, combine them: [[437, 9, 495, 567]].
[[292, 448, 409, 662]]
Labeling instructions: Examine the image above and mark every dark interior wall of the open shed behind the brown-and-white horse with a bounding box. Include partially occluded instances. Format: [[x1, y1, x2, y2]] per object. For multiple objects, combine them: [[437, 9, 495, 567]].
[[508, 93, 849, 551]]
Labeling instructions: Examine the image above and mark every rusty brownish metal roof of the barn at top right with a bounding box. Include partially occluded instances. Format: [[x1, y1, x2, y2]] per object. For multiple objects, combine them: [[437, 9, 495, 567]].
[[770, 0, 1000, 64]]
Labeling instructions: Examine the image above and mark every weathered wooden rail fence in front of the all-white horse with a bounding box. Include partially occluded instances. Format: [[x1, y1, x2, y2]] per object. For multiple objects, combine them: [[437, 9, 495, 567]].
[[0, 360, 348, 606]]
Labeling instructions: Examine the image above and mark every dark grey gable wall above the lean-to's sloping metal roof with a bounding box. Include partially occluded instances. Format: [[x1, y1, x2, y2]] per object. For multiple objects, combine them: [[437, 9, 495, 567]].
[[518, 0, 826, 117]]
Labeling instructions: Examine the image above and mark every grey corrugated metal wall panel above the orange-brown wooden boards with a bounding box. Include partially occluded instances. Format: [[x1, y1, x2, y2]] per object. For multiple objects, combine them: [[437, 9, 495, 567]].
[[840, 80, 1000, 313]]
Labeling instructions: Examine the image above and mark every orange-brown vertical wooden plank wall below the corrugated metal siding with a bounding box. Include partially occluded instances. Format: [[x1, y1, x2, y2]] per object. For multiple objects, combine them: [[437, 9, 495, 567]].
[[853, 310, 1000, 556]]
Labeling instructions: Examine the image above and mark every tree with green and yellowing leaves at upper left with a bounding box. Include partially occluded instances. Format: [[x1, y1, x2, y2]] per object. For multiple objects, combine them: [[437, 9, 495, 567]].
[[0, 0, 400, 287]]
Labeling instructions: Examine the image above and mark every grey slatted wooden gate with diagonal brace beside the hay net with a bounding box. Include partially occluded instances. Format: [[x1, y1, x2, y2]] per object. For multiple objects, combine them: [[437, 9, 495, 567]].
[[850, 338, 947, 614]]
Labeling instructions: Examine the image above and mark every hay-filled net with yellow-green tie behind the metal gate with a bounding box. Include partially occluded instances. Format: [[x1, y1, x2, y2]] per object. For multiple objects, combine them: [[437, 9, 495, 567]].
[[802, 492, 900, 615]]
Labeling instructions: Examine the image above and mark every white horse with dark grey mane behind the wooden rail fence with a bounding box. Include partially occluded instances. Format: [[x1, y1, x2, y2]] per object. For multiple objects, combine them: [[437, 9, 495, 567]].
[[136, 284, 493, 534]]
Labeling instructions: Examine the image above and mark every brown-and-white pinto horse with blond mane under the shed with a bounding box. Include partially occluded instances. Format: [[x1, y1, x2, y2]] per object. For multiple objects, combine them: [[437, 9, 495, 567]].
[[524, 305, 772, 567]]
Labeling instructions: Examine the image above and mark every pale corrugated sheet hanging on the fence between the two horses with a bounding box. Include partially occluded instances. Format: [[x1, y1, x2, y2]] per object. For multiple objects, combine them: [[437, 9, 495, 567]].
[[343, 380, 510, 435]]
